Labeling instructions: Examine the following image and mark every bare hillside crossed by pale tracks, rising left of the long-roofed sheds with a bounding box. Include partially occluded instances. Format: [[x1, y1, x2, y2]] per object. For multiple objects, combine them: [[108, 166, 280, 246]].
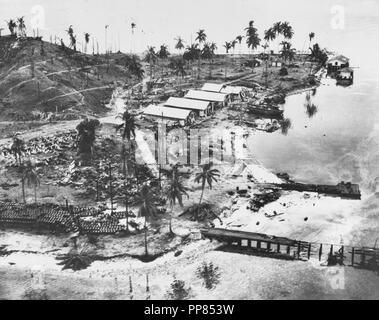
[[0, 36, 137, 120]]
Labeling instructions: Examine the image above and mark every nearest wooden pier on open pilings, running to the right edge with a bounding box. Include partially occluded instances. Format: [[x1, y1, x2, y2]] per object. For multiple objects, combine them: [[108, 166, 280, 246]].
[[201, 229, 379, 272]]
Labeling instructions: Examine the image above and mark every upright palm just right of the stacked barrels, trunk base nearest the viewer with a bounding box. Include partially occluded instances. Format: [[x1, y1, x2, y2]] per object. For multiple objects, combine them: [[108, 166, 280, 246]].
[[134, 184, 158, 256]]
